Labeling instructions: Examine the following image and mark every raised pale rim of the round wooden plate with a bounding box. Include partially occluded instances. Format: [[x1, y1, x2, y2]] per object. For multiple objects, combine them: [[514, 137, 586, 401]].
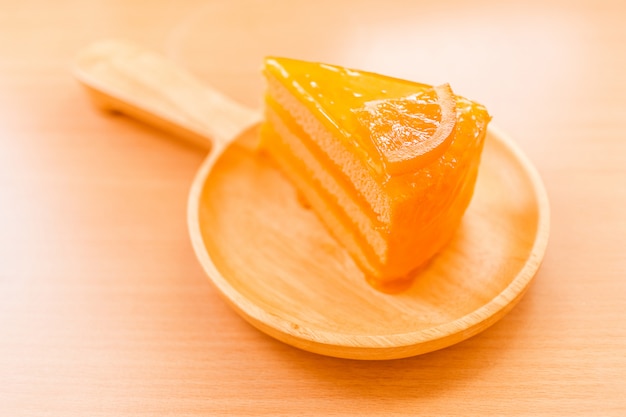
[[187, 123, 550, 359]]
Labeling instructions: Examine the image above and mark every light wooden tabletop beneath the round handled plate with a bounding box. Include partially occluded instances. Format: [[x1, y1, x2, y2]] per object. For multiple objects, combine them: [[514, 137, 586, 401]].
[[0, 0, 626, 416]]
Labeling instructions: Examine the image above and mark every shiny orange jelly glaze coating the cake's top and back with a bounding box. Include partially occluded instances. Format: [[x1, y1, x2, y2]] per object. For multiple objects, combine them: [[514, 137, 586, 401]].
[[265, 58, 490, 292]]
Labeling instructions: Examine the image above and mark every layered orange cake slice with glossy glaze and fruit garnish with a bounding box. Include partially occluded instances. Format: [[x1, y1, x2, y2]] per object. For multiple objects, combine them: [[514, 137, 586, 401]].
[[261, 58, 490, 290]]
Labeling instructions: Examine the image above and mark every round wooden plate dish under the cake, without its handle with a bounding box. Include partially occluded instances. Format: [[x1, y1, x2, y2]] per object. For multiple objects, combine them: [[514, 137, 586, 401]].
[[189, 122, 549, 360]]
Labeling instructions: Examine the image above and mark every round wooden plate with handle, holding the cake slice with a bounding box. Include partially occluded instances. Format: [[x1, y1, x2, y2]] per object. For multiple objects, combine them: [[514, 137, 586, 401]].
[[76, 41, 549, 359]]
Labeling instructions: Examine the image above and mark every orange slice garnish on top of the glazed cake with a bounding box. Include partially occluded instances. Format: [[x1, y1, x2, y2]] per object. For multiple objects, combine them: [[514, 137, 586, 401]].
[[354, 84, 456, 175]]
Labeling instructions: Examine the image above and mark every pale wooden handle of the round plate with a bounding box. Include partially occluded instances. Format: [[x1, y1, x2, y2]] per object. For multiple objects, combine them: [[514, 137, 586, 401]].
[[75, 40, 259, 148]]
